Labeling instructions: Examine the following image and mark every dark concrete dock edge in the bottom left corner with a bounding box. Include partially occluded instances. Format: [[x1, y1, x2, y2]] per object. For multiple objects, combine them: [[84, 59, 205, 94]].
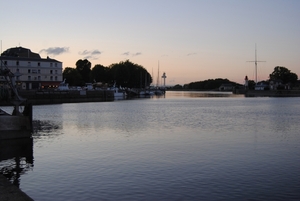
[[0, 174, 33, 201]]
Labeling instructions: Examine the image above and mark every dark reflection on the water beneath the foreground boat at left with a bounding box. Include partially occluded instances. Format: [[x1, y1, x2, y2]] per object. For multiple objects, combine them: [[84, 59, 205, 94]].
[[0, 138, 33, 187]]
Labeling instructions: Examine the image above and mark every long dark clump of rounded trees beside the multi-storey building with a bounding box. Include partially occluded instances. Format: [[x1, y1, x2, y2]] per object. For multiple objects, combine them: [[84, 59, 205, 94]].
[[63, 59, 152, 88]]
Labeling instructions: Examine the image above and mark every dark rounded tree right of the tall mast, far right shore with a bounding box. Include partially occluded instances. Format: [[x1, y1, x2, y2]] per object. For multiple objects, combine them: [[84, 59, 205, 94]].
[[269, 66, 298, 84]]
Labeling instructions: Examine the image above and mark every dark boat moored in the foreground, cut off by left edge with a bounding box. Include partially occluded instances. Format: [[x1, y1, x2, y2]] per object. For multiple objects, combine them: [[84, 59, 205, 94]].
[[0, 61, 32, 140]]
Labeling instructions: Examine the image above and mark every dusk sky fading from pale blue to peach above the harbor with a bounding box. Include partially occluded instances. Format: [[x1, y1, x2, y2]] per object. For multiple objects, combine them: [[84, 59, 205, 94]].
[[0, 0, 300, 85]]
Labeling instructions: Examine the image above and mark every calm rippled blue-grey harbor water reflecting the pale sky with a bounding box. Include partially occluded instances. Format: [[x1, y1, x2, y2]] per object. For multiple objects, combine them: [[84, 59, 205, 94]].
[[0, 91, 300, 201]]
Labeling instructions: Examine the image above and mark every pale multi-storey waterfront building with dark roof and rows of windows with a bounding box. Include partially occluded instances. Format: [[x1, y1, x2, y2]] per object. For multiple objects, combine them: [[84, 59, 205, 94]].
[[0, 47, 63, 90]]
